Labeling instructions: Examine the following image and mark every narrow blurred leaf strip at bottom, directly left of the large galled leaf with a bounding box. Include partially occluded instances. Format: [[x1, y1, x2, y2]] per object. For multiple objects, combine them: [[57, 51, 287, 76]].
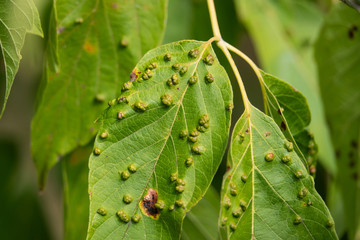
[[62, 145, 92, 240]]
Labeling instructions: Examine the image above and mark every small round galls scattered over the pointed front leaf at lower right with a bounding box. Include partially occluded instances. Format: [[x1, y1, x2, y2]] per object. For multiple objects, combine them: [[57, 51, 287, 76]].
[[221, 132, 334, 231]]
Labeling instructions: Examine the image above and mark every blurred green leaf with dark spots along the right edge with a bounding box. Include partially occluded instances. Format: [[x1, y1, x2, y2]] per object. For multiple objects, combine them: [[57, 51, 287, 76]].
[[316, 4, 360, 239]]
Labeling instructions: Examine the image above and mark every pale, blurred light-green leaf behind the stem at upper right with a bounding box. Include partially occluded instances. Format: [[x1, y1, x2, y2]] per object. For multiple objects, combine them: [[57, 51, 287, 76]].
[[235, 0, 336, 175]]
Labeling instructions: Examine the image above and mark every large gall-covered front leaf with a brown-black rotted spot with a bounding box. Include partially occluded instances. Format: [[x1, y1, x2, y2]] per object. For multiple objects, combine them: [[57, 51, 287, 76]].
[[88, 41, 232, 239]]
